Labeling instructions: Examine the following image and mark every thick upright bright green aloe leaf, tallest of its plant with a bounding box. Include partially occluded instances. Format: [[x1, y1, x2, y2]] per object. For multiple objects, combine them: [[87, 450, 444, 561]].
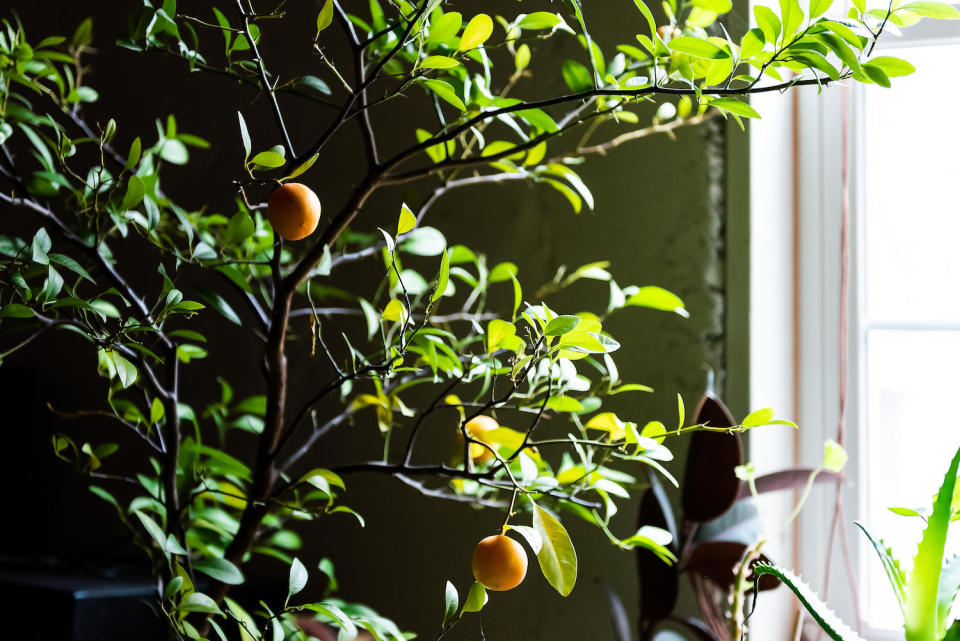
[[903, 449, 960, 641]]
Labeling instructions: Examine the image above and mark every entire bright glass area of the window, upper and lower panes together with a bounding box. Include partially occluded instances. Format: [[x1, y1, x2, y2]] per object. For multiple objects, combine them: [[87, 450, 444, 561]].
[[861, 45, 960, 629]]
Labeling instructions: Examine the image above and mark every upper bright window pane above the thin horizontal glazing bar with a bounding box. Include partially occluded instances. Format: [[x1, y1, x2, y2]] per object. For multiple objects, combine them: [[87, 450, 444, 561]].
[[864, 45, 960, 321]]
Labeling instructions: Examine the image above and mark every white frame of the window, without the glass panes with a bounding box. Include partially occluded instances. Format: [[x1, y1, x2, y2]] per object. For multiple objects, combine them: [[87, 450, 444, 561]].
[[750, 11, 960, 641]]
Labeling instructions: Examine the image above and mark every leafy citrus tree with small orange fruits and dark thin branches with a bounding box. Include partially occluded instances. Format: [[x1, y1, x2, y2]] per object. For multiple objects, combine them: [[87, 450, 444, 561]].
[[0, 0, 957, 640]]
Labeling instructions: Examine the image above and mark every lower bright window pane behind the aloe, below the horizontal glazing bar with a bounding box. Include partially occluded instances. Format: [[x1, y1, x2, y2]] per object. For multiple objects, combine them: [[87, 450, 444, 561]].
[[865, 330, 960, 628]]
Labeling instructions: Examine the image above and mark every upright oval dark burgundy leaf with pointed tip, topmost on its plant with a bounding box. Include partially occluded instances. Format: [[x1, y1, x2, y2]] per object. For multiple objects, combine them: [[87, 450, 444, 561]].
[[681, 395, 743, 523]]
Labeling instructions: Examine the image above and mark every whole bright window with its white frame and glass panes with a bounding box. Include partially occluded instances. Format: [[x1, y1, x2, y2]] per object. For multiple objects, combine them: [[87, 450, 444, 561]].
[[750, 7, 960, 639]]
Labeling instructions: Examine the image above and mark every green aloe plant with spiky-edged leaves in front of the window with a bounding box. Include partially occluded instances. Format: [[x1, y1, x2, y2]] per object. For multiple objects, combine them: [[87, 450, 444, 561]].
[[754, 442, 960, 641]]
